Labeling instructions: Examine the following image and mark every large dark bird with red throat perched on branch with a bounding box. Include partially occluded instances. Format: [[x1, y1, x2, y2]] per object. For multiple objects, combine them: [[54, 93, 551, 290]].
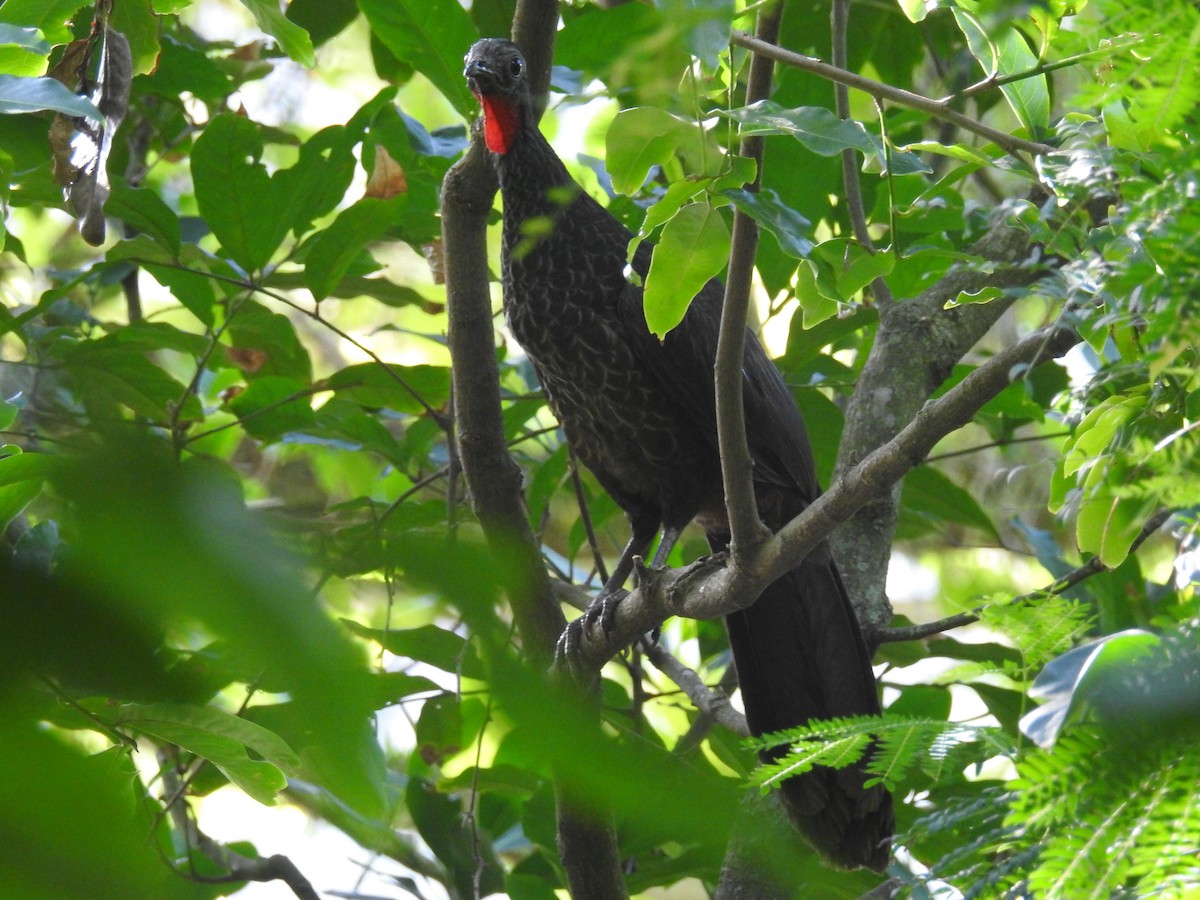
[[464, 38, 893, 870]]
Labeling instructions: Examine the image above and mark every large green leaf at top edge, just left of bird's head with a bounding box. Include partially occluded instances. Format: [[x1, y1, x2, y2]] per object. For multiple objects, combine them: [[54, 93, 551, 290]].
[[359, 0, 479, 118]]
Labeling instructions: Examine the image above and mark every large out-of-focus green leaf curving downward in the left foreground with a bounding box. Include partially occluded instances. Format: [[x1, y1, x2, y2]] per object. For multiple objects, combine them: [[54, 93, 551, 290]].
[[55, 448, 386, 817]]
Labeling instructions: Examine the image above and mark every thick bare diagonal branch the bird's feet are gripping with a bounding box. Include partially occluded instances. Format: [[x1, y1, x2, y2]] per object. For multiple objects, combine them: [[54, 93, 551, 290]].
[[561, 324, 1079, 670]]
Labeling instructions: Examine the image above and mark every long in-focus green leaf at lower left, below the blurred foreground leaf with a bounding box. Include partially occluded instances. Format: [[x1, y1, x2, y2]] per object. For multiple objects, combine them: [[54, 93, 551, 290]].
[[109, 703, 300, 806]]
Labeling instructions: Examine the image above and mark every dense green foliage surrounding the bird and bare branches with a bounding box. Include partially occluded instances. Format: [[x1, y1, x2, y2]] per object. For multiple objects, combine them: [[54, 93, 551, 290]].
[[0, 0, 1200, 899]]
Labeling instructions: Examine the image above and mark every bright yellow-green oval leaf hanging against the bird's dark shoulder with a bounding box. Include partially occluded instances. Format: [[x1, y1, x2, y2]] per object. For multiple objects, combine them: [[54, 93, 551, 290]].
[[644, 203, 730, 340]]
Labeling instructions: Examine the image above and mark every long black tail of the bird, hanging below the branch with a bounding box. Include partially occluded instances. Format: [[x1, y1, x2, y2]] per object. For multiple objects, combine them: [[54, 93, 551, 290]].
[[714, 547, 894, 871]]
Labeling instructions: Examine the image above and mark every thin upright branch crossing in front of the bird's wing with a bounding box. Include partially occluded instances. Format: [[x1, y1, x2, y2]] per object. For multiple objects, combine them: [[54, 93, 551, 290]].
[[715, 2, 782, 556]]
